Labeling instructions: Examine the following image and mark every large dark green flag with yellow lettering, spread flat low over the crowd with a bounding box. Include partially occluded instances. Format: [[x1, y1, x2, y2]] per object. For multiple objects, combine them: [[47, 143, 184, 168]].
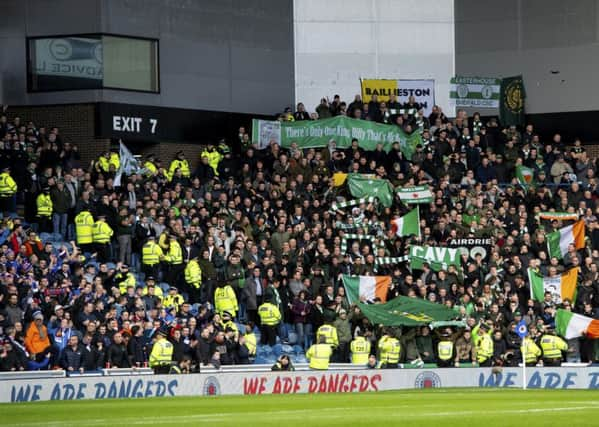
[[358, 296, 456, 326]]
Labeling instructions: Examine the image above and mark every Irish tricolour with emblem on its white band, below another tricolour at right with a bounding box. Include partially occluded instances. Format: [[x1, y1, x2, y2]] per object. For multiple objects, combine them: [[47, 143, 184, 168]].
[[528, 268, 578, 304]]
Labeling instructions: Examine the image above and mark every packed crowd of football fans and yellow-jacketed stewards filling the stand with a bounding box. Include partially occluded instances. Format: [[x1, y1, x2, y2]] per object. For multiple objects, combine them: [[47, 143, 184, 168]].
[[0, 92, 599, 372]]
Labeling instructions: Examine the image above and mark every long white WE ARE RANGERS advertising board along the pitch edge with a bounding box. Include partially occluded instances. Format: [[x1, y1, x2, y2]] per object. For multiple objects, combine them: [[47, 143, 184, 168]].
[[0, 367, 599, 403]]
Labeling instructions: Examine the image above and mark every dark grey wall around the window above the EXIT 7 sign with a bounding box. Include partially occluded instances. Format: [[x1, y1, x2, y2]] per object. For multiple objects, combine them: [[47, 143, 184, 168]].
[[0, 0, 294, 113]]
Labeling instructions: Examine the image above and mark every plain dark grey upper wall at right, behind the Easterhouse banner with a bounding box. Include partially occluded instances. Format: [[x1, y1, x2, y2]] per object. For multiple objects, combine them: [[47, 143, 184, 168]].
[[455, 0, 599, 114]]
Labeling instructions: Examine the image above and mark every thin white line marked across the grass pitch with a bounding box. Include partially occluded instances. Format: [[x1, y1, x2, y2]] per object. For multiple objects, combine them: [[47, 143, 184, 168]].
[[13, 404, 598, 427]]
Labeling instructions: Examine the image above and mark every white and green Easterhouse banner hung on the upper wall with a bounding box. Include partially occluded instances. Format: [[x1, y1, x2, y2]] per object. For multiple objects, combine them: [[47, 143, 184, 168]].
[[449, 76, 501, 108]]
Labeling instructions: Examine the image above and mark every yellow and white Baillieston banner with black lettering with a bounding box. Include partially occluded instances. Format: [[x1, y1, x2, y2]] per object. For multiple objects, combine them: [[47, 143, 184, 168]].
[[360, 79, 435, 116]]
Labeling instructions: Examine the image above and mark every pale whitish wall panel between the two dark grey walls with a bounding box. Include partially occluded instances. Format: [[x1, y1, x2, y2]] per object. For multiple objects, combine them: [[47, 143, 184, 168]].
[[294, 0, 454, 111]]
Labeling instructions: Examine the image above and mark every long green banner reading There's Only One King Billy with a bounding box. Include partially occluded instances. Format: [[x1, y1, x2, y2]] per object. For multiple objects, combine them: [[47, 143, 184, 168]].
[[252, 116, 422, 160]]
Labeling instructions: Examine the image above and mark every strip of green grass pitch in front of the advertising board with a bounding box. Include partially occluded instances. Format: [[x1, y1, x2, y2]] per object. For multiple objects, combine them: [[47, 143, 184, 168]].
[[0, 389, 599, 427]]
